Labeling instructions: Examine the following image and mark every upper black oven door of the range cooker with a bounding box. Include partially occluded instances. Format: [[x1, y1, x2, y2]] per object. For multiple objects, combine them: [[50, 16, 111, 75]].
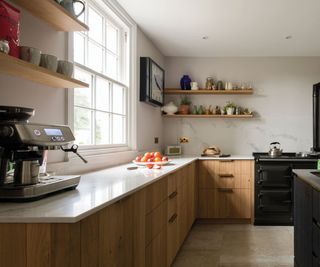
[[255, 164, 293, 188]]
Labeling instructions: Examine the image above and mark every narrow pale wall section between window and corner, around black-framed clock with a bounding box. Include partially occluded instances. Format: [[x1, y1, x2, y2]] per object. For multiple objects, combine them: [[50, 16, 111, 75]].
[[137, 29, 164, 151]]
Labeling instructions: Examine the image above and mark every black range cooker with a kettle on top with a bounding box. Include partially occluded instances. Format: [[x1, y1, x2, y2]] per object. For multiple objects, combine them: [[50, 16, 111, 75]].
[[253, 153, 317, 225]]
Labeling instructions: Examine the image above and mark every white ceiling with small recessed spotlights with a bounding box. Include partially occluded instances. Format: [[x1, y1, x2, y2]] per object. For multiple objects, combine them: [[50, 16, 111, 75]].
[[118, 0, 320, 57]]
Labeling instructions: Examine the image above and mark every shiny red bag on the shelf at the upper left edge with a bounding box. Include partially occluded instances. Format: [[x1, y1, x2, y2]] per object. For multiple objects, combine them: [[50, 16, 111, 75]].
[[0, 0, 20, 58]]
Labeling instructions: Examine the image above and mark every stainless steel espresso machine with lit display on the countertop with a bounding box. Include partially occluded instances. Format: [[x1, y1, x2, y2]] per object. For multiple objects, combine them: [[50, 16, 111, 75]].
[[0, 106, 86, 201]]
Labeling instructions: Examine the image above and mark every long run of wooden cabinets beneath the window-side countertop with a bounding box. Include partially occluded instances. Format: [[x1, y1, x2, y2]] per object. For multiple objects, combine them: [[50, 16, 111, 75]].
[[0, 163, 196, 267]]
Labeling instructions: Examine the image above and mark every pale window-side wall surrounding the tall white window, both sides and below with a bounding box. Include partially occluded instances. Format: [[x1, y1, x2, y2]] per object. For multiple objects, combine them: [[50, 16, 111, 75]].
[[0, 4, 164, 173]]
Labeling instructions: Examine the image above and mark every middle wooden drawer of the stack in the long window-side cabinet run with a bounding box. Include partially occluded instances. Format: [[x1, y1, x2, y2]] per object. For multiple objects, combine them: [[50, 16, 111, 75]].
[[146, 201, 167, 245]]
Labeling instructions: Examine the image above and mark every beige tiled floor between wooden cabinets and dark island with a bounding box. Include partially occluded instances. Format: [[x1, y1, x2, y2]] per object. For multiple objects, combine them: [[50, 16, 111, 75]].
[[173, 224, 293, 267]]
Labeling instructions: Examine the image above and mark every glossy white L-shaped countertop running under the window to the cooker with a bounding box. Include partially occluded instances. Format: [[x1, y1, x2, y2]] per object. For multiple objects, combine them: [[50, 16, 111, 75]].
[[0, 156, 253, 223]]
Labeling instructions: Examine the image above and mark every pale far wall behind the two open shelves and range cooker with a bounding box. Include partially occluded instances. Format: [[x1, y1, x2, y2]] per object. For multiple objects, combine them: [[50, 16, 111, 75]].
[[164, 57, 320, 154]]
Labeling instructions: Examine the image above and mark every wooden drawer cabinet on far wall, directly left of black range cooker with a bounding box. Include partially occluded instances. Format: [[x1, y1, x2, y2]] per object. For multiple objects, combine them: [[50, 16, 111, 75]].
[[198, 160, 253, 219]]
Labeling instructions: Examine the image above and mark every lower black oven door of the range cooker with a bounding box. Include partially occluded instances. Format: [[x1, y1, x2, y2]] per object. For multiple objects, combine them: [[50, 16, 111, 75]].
[[256, 190, 293, 214]]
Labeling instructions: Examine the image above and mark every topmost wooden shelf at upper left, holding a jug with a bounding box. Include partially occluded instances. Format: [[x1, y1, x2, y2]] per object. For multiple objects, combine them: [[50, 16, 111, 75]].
[[13, 0, 89, 32]]
